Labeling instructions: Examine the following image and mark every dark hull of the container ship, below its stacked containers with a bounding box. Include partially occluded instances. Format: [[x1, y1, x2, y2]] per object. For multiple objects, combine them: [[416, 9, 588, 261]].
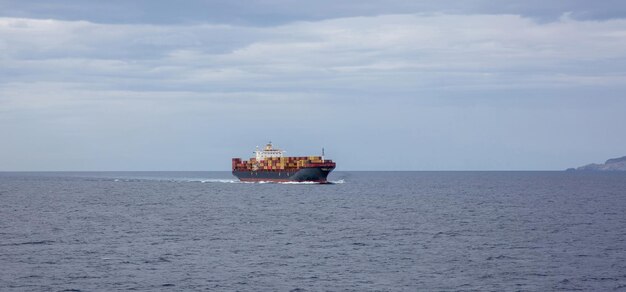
[[233, 167, 333, 183]]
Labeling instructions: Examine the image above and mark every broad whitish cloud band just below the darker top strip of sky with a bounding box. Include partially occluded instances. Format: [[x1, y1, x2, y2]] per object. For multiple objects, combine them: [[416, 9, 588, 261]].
[[0, 15, 626, 99]]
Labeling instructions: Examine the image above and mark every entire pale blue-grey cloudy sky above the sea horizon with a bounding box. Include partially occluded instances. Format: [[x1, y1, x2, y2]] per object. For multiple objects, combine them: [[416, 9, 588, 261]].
[[0, 0, 626, 171]]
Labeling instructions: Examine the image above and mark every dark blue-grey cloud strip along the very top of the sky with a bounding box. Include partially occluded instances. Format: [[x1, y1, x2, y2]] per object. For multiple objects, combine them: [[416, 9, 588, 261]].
[[0, 0, 626, 26]]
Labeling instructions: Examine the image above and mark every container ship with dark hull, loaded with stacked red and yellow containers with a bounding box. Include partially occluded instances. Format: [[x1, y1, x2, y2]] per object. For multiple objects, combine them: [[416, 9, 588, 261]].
[[233, 142, 335, 183]]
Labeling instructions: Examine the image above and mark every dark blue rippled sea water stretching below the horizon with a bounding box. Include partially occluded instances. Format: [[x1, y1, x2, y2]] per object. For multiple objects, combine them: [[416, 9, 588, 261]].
[[0, 172, 626, 291]]
